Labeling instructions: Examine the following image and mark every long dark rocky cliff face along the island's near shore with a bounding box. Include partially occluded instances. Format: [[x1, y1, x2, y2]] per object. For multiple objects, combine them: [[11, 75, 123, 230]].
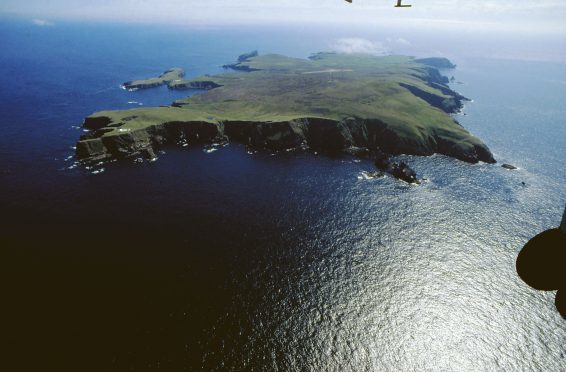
[[76, 117, 495, 163]]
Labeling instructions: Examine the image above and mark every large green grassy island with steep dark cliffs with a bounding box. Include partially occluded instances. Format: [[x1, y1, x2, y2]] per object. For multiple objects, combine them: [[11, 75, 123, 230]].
[[76, 51, 495, 180]]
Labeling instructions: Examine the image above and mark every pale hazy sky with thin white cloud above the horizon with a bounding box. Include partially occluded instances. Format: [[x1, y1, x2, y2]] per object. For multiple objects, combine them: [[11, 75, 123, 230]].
[[0, 0, 566, 35]]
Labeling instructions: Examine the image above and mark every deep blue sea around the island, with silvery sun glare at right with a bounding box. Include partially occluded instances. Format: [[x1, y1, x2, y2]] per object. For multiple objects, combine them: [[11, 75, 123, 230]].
[[0, 19, 566, 371]]
